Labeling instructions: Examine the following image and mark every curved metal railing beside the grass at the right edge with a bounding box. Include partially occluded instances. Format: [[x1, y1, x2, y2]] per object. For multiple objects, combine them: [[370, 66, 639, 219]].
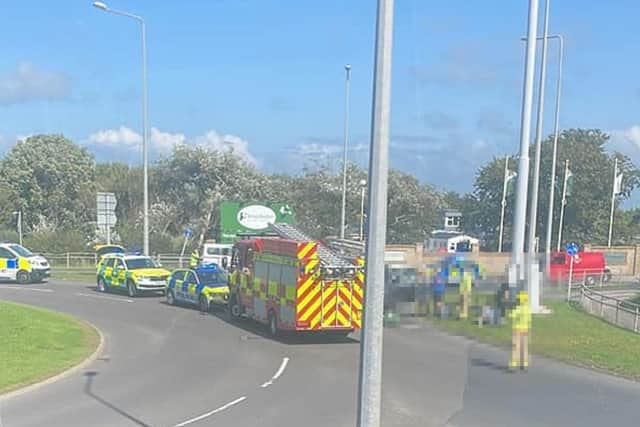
[[567, 284, 640, 333]]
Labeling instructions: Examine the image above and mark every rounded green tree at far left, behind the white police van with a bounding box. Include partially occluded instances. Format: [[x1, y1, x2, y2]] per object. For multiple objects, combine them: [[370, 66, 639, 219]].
[[0, 135, 95, 230]]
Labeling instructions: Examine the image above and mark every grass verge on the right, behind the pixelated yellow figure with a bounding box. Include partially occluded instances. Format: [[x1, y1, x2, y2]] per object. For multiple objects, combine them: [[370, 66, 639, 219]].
[[433, 302, 640, 380]]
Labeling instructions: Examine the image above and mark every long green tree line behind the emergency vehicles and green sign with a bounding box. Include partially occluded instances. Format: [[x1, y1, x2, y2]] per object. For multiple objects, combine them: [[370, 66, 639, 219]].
[[0, 135, 443, 252]]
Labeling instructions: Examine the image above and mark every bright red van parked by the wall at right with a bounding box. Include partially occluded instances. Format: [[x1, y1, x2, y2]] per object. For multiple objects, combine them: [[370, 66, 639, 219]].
[[549, 252, 611, 285]]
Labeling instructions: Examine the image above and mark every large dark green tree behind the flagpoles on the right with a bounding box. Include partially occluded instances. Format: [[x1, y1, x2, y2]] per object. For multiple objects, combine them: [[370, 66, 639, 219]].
[[463, 129, 640, 248]]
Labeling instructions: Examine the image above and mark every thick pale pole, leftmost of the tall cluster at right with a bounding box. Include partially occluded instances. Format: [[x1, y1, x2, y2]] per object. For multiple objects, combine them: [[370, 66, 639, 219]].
[[510, 0, 538, 270]]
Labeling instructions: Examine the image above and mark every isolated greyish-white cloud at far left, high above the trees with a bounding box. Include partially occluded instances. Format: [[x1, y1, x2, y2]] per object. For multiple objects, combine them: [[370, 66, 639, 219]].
[[0, 62, 70, 105]]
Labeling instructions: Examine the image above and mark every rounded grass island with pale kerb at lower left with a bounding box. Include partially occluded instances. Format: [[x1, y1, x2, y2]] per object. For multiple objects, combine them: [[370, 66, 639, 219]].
[[0, 301, 100, 393]]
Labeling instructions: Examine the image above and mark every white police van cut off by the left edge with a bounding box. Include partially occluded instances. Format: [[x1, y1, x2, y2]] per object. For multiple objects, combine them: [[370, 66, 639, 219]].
[[0, 243, 51, 283]]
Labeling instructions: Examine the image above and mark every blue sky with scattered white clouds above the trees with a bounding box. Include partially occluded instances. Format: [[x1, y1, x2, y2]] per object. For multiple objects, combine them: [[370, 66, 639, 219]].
[[0, 0, 640, 200]]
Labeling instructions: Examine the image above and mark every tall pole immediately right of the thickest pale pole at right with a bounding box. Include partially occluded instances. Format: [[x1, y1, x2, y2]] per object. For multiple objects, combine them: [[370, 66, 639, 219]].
[[527, 0, 550, 313]]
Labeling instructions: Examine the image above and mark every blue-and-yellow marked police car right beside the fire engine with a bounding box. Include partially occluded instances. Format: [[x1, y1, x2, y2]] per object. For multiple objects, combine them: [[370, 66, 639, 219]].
[[166, 264, 229, 312]]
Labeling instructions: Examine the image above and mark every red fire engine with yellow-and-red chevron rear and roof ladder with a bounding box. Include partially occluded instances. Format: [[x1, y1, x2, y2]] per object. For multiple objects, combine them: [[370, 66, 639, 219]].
[[228, 224, 364, 336]]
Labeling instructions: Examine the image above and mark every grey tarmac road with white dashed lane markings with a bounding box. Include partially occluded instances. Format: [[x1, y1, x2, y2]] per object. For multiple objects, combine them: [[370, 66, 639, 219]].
[[0, 281, 640, 427]]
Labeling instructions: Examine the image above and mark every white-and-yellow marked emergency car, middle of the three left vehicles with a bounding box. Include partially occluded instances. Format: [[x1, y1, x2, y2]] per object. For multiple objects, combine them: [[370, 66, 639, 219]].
[[96, 254, 171, 297]]
